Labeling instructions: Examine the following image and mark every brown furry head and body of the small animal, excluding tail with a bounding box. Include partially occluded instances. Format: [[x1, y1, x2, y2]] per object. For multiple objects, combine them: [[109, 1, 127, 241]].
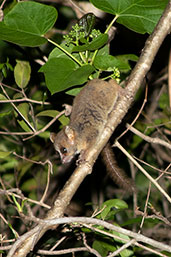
[[51, 79, 119, 163]]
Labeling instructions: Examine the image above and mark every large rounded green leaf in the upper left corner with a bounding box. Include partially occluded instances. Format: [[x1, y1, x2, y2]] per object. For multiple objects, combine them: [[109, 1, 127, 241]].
[[0, 1, 57, 46]]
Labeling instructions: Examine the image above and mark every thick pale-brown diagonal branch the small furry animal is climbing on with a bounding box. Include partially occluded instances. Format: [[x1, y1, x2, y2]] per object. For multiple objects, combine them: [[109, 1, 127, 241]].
[[8, 1, 171, 257]]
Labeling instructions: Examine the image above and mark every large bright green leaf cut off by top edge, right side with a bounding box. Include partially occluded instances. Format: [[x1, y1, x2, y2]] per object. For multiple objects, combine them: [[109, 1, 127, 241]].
[[90, 0, 168, 34]]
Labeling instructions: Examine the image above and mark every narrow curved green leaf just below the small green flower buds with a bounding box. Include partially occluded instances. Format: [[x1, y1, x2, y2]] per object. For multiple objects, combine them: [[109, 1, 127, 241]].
[[72, 34, 108, 52]]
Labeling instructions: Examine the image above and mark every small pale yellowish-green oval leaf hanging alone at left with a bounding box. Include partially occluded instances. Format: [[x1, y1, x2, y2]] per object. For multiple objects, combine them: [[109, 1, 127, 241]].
[[14, 60, 31, 88]]
